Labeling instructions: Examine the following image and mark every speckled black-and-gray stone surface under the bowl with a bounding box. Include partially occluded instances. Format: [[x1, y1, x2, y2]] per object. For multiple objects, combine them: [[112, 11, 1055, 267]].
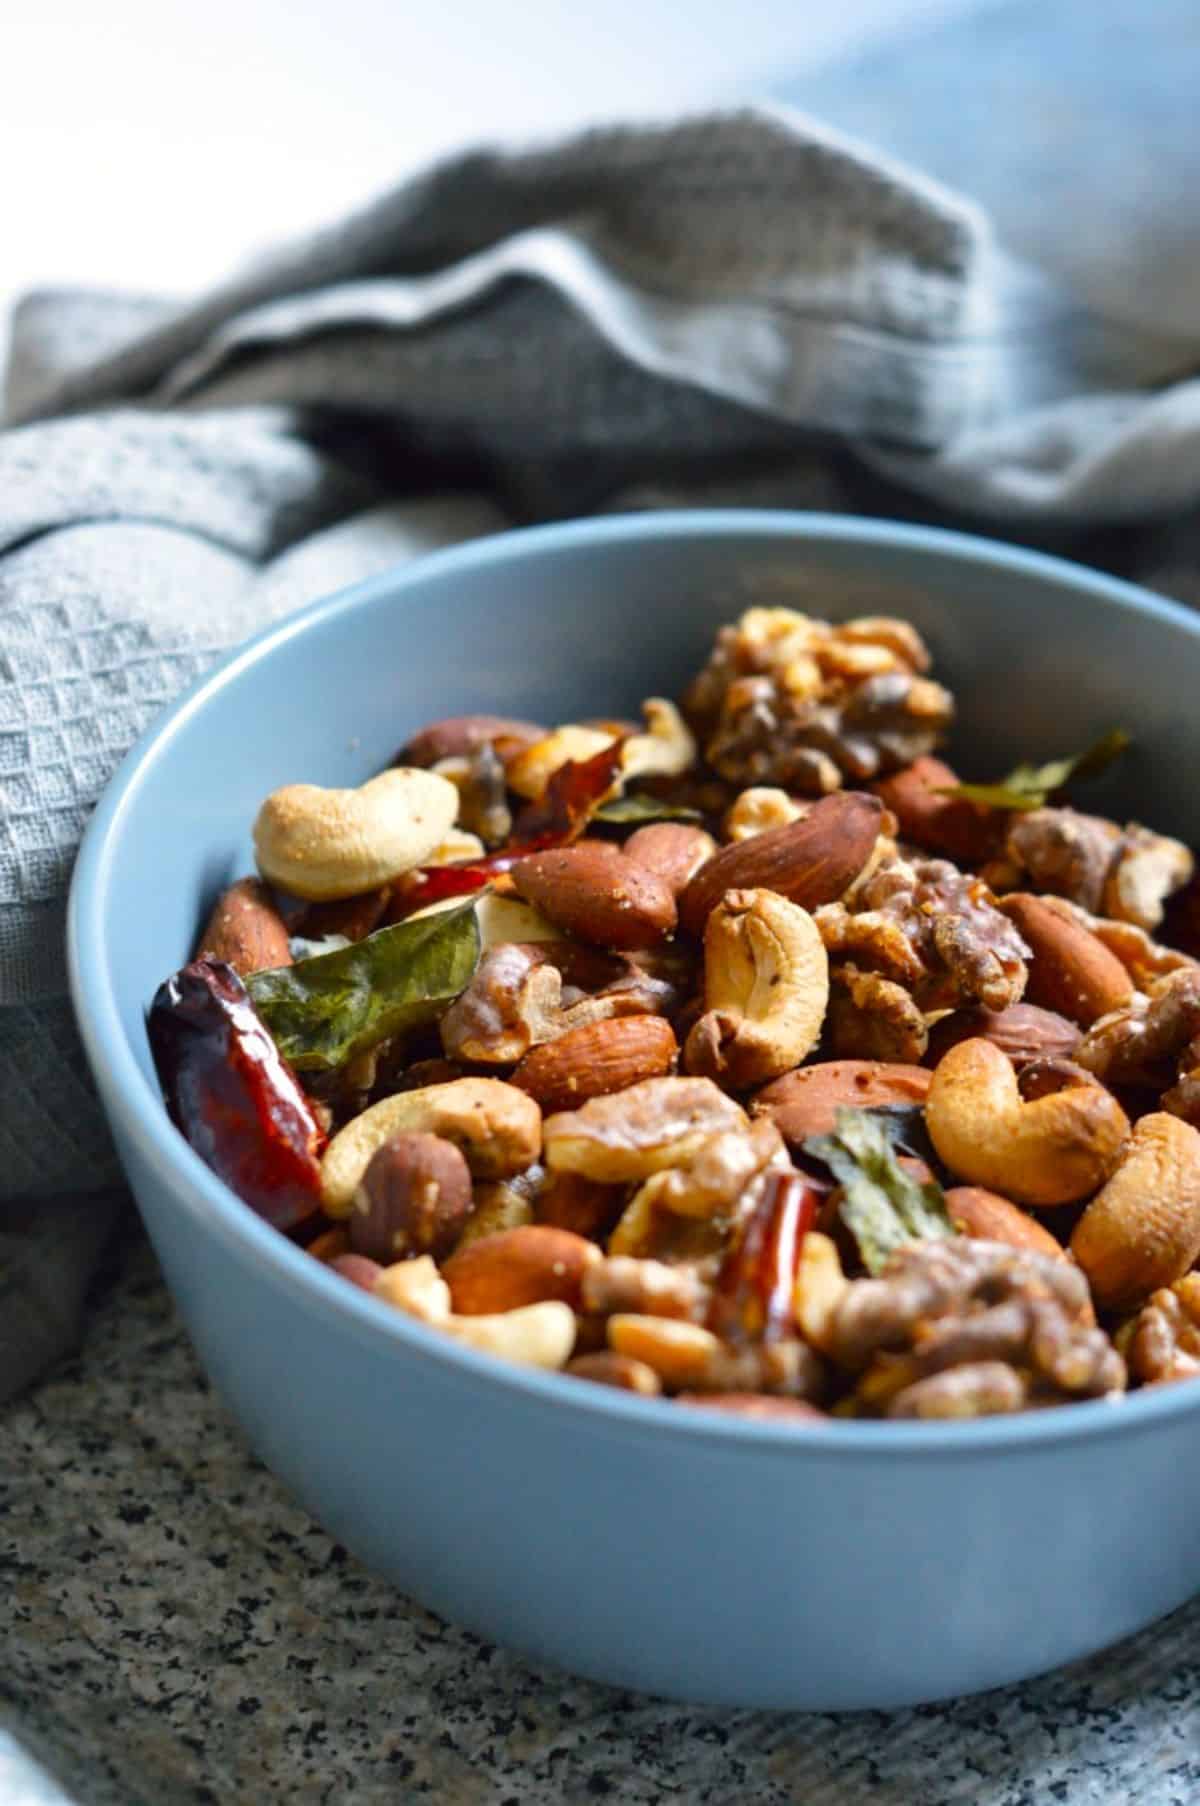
[[0, 1232, 1200, 1806]]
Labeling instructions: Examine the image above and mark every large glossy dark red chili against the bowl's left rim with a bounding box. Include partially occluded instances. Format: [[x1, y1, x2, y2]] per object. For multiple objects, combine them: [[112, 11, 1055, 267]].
[[146, 959, 325, 1230]]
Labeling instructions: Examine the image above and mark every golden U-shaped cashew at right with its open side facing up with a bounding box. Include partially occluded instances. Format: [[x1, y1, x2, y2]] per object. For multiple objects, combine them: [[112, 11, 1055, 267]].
[[925, 1038, 1130, 1205]]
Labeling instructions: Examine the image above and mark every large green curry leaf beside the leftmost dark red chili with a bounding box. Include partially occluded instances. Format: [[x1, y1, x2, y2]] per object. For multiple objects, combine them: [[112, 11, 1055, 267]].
[[246, 899, 479, 1071]]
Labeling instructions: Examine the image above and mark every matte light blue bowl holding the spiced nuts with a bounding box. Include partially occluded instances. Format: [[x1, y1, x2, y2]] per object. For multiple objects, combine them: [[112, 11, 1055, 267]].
[[70, 513, 1200, 1708]]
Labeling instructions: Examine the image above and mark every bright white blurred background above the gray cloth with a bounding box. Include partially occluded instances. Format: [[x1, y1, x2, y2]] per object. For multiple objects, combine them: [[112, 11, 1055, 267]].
[[0, 0, 994, 307]]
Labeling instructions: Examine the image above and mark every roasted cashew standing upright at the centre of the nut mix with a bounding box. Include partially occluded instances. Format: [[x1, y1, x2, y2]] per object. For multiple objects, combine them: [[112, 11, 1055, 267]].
[[685, 890, 830, 1091]]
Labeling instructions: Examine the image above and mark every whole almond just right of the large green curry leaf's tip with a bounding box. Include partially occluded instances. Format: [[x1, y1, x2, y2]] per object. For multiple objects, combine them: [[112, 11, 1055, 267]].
[[511, 840, 676, 952]]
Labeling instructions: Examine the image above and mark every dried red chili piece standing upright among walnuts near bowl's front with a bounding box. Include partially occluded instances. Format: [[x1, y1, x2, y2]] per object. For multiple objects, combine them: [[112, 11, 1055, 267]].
[[708, 1172, 824, 1342]]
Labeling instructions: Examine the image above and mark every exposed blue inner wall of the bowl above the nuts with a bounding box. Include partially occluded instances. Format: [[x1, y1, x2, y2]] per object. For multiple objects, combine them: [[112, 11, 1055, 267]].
[[87, 515, 1200, 1107]]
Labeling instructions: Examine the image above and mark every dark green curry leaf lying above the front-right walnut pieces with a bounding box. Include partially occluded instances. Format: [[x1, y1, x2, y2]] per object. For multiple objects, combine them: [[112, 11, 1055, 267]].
[[804, 1109, 958, 1273]]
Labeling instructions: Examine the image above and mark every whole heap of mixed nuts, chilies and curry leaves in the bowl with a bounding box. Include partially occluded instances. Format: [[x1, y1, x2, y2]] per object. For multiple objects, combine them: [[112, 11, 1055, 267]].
[[148, 609, 1200, 1423]]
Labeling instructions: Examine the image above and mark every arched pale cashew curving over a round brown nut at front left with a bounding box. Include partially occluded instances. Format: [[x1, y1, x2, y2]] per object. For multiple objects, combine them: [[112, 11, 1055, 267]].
[[322, 1078, 542, 1217]]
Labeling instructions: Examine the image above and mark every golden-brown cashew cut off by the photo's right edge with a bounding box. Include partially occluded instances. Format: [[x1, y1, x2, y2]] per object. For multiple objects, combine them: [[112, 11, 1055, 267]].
[[1059, 1093, 1200, 1309]]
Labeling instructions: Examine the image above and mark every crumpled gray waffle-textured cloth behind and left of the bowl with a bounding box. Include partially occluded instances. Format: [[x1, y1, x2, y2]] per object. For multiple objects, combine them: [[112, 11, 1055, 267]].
[[0, 98, 1200, 1396]]
